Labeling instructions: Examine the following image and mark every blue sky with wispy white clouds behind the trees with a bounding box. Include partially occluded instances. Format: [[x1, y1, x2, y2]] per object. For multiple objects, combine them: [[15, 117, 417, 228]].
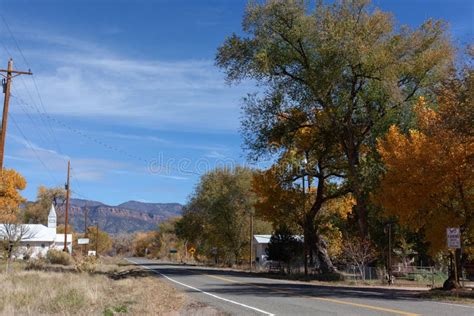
[[0, 0, 474, 204]]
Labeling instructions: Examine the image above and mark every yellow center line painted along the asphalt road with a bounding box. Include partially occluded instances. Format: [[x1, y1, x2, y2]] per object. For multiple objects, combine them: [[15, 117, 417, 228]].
[[200, 273, 419, 316]]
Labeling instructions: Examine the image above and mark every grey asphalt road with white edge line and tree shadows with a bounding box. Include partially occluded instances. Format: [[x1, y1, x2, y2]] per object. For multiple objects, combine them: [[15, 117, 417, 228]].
[[129, 258, 474, 316]]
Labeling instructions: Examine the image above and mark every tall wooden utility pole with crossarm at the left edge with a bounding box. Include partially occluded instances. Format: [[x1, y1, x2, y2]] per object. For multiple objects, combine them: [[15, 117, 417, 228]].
[[0, 58, 33, 172]]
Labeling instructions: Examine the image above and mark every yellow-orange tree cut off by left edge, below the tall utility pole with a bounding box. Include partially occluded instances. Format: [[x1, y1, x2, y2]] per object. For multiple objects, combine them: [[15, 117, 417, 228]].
[[0, 169, 26, 223]]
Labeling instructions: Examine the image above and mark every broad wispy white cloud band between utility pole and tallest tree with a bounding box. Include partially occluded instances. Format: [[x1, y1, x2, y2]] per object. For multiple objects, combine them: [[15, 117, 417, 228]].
[[5, 30, 251, 132]]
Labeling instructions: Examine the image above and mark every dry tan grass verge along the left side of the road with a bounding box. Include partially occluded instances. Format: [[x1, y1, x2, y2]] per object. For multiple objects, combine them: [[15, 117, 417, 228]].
[[0, 263, 185, 315]]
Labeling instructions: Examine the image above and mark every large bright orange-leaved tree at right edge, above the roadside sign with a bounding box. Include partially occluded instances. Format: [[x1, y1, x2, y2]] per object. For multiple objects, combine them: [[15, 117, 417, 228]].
[[376, 87, 474, 254]]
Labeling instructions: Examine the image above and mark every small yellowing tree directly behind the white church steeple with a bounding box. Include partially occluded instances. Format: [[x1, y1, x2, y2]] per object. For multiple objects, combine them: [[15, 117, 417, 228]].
[[22, 185, 66, 224]]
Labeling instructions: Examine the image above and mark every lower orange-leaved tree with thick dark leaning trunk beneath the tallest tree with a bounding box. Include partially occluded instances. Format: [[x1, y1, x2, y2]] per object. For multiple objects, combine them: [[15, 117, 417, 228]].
[[253, 159, 348, 273]]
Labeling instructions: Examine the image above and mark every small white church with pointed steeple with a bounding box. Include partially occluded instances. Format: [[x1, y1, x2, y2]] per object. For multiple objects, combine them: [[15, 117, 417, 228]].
[[0, 205, 72, 258]]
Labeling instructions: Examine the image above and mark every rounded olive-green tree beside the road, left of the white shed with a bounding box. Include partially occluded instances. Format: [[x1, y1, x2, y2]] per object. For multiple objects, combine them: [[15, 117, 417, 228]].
[[177, 167, 257, 264]]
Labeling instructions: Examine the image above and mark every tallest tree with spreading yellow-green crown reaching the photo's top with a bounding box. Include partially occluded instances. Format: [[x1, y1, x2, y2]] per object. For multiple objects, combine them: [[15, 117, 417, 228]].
[[216, 0, 452, 236]]
